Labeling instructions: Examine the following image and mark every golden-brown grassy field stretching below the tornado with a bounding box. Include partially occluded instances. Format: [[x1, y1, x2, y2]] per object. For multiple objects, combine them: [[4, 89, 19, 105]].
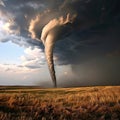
[[0, 86, 120, 120]]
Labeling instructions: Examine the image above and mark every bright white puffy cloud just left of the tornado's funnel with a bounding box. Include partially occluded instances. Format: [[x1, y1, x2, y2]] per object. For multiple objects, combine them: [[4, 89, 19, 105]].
[[0, 47, 45, 72]]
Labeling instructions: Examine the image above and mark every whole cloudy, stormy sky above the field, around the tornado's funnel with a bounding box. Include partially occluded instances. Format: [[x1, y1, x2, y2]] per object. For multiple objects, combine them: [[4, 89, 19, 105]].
[[0, 0, 120, 87]]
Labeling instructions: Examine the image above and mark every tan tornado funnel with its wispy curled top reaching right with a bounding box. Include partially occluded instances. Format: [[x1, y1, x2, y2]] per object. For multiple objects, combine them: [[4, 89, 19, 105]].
[[41, 14, 76, 87]]
